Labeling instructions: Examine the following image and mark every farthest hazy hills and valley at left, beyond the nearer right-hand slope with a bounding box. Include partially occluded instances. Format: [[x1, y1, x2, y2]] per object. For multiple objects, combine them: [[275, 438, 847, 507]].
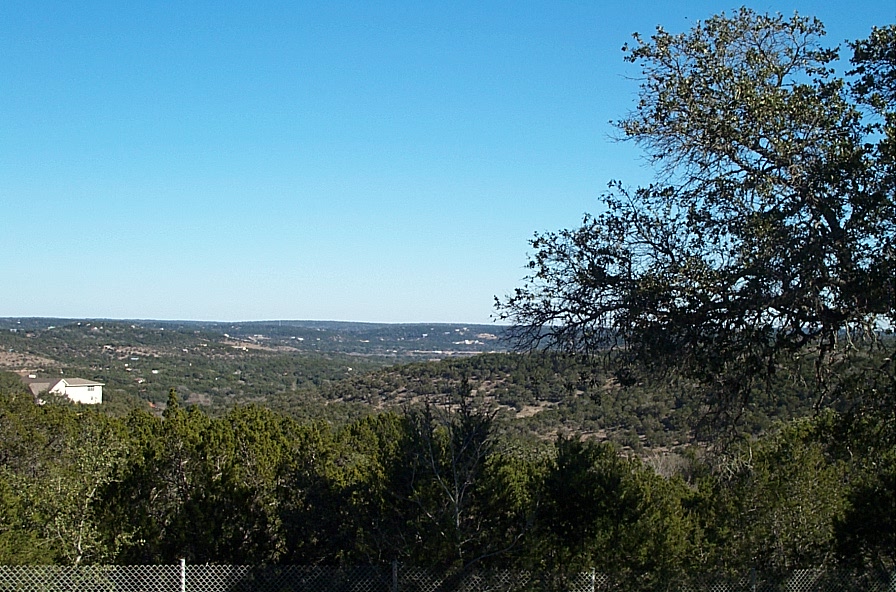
[[0, 319, 506, 408]]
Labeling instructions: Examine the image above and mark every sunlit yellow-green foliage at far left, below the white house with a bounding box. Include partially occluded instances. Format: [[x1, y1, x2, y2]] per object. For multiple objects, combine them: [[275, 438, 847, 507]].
[[0, 375, 124, 564]]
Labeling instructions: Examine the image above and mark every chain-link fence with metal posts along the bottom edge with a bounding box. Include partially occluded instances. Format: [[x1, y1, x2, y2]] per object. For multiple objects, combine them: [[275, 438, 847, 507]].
[[0, 563, 896, 592]]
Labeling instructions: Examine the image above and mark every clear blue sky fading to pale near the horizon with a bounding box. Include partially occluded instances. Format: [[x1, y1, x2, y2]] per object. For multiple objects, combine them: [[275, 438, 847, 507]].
[[0, 0, 896, 323]]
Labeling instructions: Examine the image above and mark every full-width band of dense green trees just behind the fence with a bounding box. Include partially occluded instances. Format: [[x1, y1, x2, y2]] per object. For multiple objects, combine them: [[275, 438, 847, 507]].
[[0, 368, 894, 576]]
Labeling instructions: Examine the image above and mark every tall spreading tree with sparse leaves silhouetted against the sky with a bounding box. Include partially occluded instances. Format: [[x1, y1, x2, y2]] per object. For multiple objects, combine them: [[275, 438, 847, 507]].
[[497, 8, 896, 432]]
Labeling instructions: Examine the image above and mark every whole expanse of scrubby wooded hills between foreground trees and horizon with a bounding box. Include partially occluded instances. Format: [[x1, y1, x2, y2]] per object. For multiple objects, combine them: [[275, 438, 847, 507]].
[[0, 319, 824, 452]]
